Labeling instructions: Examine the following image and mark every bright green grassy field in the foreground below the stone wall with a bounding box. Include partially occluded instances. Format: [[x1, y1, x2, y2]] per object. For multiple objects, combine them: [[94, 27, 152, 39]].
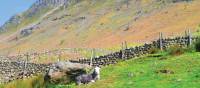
[[2, 52, 200, 88]]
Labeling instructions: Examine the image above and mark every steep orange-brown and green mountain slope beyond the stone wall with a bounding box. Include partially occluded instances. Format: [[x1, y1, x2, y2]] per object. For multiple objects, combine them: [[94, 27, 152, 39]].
[[0, 0, 200, 54]]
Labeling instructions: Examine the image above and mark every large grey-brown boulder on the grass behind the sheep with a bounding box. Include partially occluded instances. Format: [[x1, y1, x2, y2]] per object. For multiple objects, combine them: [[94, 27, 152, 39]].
[[45, 62, 91, 84]]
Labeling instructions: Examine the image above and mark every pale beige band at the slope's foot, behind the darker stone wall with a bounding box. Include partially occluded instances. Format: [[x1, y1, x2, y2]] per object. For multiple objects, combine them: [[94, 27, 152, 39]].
[[0, 48, 113, 63]]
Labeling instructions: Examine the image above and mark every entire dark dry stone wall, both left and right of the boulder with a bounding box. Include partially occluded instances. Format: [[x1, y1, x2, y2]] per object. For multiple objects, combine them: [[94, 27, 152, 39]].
[[0, 37, 198, 83]]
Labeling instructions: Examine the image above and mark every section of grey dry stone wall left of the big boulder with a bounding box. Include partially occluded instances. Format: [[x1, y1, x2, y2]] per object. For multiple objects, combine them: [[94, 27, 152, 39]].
[[0, 62, 49, 83]]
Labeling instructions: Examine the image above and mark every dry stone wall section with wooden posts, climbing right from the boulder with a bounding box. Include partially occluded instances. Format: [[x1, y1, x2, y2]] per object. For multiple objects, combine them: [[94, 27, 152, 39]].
[[71, 37, 198, 66]]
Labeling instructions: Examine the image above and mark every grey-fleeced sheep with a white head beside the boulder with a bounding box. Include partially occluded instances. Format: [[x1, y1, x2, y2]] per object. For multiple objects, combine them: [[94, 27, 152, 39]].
[[75, 67, 100, 85]]
